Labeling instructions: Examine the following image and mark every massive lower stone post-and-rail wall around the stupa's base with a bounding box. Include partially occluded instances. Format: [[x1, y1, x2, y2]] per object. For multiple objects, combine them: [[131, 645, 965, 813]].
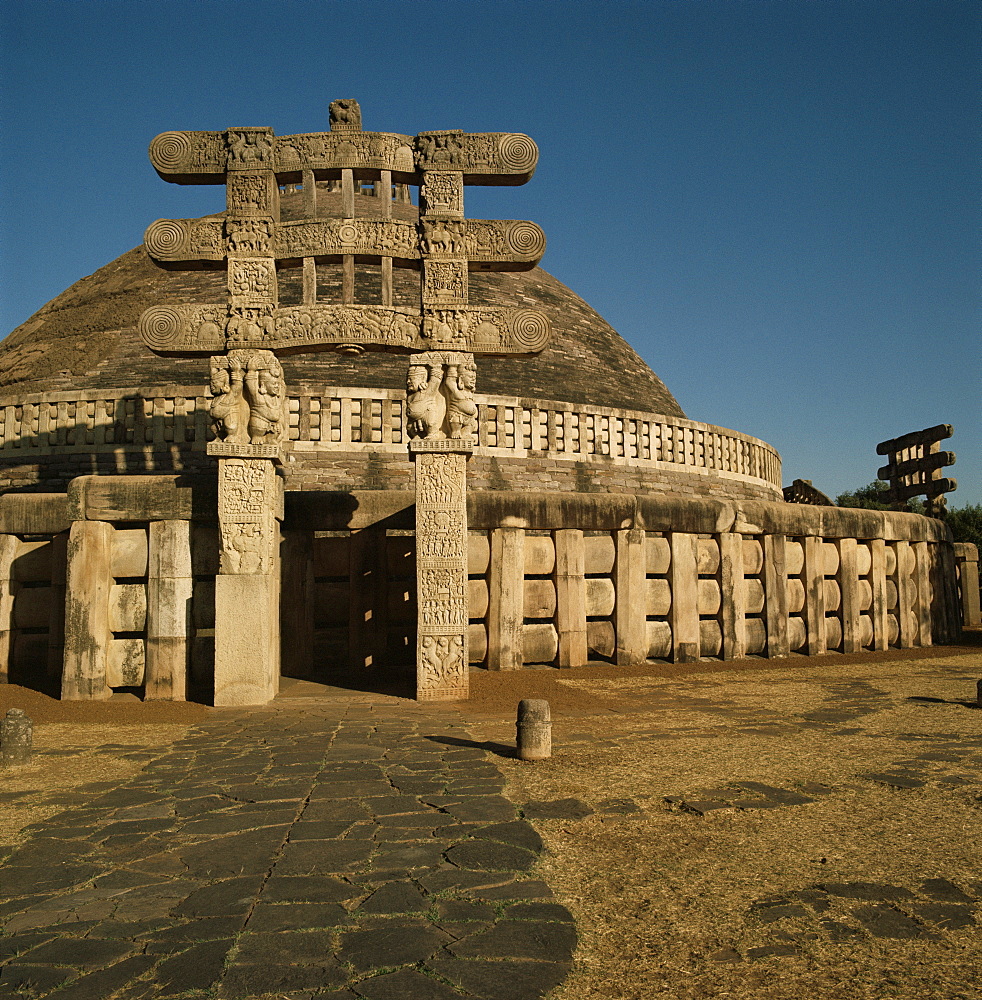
[[0, 476, 978, 697]]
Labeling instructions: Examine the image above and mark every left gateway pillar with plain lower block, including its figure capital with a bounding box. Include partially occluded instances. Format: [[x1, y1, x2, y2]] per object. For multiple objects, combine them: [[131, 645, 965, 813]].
[[208, 351, 285, 706]]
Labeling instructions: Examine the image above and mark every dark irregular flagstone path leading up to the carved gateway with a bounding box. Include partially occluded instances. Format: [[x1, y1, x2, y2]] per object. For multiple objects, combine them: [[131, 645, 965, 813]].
[[0, 703, 576, 1000]]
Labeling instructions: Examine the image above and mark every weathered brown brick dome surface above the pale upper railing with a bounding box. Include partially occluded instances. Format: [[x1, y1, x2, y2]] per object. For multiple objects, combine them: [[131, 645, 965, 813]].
[[0, 185, 684, 417]]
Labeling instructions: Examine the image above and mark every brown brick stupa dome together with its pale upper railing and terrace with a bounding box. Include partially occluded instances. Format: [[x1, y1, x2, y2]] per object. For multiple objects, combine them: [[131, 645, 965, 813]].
[[0, 181, 781, 499]]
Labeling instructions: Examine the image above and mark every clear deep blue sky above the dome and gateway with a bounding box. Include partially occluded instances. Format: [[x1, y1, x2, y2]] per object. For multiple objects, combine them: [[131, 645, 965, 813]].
[[0, 0, 982, 506]]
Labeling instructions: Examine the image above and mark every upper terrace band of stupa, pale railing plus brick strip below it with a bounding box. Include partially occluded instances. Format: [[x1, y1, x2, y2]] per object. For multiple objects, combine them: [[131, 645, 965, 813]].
[[0, 386, 781, 499]]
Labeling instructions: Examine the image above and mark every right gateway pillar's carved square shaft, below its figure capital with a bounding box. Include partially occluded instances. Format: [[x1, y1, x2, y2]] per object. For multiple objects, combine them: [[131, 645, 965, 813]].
[[409, 438, 473, 701]]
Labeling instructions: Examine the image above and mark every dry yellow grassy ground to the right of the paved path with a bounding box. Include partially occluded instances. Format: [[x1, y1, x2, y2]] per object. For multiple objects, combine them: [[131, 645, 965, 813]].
[[466, 654, 982, 1000]]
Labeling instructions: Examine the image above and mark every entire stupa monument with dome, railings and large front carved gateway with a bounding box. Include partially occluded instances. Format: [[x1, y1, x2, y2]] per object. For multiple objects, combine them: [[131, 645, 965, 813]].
[[0, 100, 977, 705]]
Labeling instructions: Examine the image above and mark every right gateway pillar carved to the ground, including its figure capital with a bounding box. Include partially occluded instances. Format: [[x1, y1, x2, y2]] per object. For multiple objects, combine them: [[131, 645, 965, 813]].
[[406, 352, 477, 701]]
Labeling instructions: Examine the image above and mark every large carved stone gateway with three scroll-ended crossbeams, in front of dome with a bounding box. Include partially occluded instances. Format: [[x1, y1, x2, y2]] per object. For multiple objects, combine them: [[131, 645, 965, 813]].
[[140, 100, 550, 705]]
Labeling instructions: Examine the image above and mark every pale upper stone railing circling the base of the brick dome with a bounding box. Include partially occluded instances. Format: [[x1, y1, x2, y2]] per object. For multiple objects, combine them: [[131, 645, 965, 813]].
[[0, 386, 781, 490]]
